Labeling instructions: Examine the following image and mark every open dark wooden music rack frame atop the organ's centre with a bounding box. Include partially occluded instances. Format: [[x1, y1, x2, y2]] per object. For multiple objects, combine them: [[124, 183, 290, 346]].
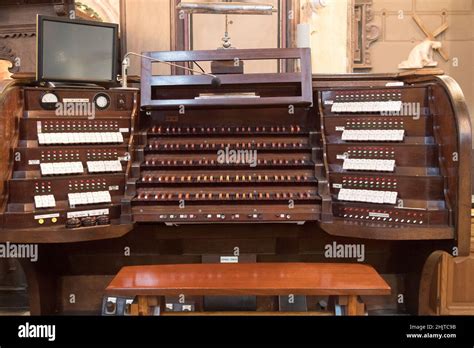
[[141, 48, 313, 108]]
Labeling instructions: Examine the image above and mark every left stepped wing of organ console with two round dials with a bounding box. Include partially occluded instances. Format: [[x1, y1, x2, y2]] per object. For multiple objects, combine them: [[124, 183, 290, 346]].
[[3, 87, 137, 233]]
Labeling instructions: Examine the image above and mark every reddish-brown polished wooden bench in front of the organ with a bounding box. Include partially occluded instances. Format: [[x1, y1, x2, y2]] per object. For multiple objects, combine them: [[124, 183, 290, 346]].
[[106, 263, 390, 315]]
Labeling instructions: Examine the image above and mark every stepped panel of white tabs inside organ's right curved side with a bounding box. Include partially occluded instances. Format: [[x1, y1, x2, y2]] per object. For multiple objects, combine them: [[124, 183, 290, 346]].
[[321, 87, 442, 223]]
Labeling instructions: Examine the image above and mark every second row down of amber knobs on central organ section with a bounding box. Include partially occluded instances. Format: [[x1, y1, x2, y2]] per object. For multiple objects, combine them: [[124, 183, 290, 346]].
[[148, 140, 305, 150]]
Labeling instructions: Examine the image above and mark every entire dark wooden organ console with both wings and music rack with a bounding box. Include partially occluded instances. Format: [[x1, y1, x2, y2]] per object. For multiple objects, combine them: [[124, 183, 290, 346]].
[[0, 49, 471, 314]]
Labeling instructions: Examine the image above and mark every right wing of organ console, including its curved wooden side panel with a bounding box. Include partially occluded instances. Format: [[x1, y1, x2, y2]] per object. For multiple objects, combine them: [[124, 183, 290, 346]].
[[318, 79, 467, 252]]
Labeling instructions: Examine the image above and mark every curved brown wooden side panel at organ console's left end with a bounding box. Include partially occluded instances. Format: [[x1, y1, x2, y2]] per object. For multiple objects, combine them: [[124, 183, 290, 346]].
[[0, 80, 23, 223]]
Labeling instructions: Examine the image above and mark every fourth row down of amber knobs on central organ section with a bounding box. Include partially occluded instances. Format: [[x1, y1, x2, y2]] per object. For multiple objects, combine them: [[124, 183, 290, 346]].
[[141, 174, 311, 183]]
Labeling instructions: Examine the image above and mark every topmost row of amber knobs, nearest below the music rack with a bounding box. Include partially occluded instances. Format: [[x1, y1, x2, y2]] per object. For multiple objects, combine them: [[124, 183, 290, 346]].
[[149, 125, 301, 135]]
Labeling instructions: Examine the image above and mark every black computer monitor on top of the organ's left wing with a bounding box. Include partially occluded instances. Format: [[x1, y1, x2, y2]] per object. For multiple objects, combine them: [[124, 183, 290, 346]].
[[36, 15, 118, 83]]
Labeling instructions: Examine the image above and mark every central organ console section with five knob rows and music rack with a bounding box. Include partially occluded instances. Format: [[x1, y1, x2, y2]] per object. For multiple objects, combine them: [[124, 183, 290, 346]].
[[132, 50, 322, 223]]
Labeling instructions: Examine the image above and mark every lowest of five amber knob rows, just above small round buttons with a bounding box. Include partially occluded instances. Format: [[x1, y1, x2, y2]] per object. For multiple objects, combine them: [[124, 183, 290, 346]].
[[137, 191, 316, 201]]
